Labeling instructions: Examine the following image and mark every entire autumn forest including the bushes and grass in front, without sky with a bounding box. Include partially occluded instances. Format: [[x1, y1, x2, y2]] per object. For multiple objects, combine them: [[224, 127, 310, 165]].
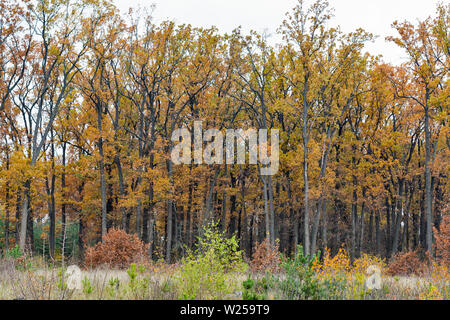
[[0, 0, 450, 300]]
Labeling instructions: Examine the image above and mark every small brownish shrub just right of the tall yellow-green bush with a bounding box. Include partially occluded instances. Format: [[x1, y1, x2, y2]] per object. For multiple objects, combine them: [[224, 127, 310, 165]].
[[250, 238, 281, 272]]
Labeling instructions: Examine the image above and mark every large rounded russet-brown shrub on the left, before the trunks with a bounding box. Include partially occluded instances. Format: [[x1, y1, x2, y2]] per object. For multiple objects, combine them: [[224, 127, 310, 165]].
[[84, 228, 148, 269]]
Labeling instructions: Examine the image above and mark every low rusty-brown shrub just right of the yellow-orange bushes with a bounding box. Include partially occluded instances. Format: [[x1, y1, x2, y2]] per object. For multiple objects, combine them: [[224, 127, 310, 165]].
[[386, 250, 431, 276]]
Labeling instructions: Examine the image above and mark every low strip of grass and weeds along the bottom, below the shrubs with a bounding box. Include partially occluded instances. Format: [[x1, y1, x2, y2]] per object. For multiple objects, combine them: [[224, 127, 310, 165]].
[[0, 258, 450, 300]]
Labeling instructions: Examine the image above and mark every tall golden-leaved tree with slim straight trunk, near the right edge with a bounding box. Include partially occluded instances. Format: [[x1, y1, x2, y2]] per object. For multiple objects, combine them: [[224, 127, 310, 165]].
[[389, 7, 449, 254]]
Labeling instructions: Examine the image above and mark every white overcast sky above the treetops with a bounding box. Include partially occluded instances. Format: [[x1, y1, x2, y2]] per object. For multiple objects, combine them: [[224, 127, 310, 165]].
[[114, 0, 442, 64]]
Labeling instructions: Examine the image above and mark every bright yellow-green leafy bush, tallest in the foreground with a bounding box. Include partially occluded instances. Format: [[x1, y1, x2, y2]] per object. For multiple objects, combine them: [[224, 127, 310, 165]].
[[177, 223, 247, 300]]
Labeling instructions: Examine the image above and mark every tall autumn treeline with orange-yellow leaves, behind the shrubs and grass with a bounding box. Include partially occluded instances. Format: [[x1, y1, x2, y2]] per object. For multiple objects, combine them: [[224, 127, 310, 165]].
[[0, 0, 450, 261]]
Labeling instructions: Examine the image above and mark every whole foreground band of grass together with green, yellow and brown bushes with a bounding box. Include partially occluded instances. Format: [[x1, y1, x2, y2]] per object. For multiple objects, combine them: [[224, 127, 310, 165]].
[[0, 224, 450, 300]]
